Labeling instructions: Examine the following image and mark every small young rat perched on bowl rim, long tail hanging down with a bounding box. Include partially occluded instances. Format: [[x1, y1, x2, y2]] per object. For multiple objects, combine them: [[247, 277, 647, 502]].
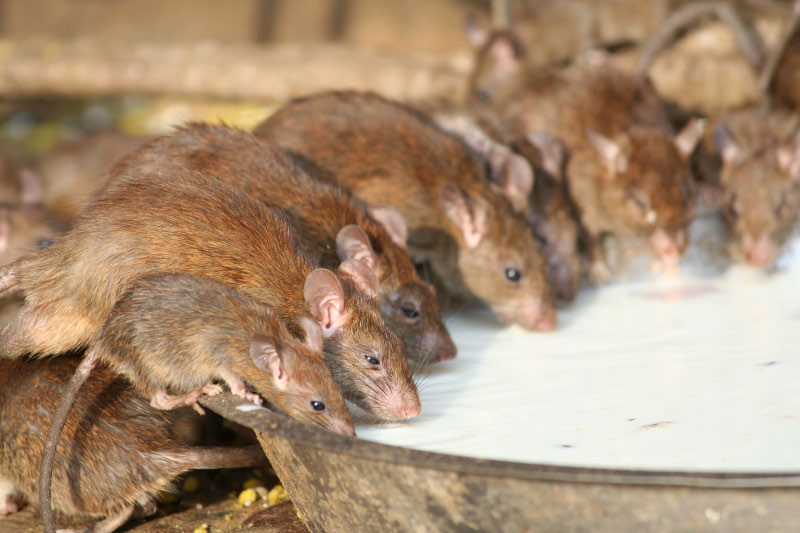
[[41, 274, 355, 532]]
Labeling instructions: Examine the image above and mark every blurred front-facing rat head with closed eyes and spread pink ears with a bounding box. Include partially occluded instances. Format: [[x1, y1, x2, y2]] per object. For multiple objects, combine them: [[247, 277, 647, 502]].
[[587, 120, 704, 262]]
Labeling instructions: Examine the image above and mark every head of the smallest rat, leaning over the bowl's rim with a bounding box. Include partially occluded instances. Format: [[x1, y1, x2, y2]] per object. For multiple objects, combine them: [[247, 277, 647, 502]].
[[250, 316, 356, 437]]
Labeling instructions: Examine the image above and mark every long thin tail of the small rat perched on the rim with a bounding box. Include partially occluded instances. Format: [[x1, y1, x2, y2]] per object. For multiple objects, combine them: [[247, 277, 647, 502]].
[[39, 348, 100, 533]]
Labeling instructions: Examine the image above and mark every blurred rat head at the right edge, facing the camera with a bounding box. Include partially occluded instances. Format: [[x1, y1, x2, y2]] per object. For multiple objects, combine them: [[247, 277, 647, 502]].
[[713, 123, 800, 268]]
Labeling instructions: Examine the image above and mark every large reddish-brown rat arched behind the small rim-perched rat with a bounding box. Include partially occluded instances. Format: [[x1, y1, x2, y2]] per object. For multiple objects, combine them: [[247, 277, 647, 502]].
[[0, 156, 421, 419]]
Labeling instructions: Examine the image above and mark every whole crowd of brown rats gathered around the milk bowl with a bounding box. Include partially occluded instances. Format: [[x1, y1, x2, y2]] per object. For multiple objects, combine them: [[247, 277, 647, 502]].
[[0, 2, 800, 531]]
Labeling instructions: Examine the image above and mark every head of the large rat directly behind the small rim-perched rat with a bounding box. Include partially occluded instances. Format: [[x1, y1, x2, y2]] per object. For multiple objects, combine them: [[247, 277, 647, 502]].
[[304, 259, 422, 420]]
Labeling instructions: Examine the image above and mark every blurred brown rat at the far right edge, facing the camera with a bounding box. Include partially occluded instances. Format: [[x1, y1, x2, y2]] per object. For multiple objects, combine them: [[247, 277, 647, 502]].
[[713, 106, 800, 268]]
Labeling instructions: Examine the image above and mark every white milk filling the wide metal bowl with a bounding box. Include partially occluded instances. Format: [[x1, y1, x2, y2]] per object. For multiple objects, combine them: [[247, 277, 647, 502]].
[[356, 218, 800, 471]]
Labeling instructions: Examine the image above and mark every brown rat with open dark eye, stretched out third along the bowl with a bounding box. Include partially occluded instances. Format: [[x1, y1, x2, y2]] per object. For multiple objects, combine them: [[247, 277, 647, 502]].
[[255, 91, 557, 331]]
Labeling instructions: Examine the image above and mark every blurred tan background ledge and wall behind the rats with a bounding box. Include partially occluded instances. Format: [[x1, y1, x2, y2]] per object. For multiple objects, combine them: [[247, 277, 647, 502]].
[[0, 0, 790, 157]]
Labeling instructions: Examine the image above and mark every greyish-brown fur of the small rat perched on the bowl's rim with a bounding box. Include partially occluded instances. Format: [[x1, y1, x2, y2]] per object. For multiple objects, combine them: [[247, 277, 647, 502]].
[[92, 274, 355, 435]]
